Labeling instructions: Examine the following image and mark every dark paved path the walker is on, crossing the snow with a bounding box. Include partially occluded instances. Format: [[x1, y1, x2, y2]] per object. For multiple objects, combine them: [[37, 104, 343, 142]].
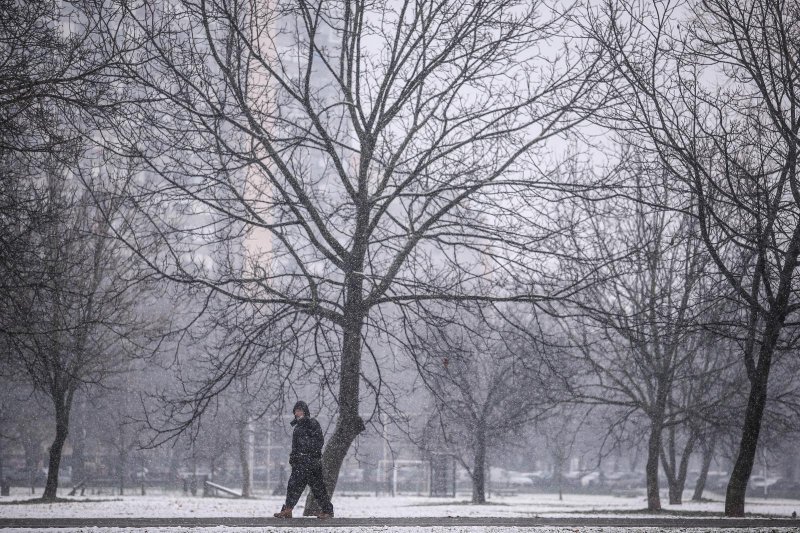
[[0, 516, 800, 531]]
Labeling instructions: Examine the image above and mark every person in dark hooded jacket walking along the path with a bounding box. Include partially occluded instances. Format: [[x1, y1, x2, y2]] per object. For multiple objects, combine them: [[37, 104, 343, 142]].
[[273, 401, 333, 518]]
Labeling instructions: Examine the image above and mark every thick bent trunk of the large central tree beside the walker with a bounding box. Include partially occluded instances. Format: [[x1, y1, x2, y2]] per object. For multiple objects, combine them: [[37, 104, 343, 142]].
[[303, 298, 366, 516]]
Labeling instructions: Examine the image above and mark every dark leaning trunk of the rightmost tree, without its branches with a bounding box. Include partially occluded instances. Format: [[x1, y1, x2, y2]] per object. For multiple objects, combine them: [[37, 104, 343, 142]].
[[725, 350, 777, 516]]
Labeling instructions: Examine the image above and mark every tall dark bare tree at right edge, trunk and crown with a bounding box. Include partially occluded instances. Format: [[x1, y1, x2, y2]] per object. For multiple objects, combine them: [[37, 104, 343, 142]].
[[593, 0, 800, 516]]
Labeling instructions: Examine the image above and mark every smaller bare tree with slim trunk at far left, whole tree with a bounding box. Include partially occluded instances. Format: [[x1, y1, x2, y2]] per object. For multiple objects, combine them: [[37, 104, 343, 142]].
[[4, 161, 159, 499]]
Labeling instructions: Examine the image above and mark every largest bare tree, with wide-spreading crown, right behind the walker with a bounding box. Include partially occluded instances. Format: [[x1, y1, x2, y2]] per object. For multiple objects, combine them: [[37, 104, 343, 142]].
[[87, 0, 604, 508]]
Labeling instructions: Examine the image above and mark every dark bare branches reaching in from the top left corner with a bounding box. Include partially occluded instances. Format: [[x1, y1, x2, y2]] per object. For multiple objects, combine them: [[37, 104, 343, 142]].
[[0, 0, 128, 300]]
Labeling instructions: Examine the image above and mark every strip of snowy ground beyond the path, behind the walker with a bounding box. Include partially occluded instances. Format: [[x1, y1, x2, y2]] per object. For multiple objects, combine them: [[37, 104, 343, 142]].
[[0, 489, 800, 518]]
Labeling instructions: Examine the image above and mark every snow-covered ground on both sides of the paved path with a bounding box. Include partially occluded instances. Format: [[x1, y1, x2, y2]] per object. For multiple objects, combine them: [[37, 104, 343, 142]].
[[0, 491, 800, 533]]
